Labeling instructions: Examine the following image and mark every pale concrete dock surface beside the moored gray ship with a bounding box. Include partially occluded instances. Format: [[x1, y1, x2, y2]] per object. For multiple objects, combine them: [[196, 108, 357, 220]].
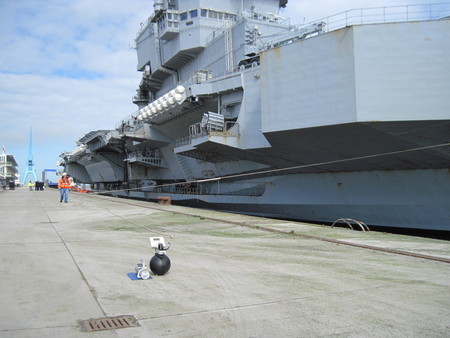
[[0, 188, 450, 337]]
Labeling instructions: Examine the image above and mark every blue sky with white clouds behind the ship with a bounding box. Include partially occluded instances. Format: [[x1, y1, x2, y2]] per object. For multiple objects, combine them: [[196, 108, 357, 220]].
[[0, 0, 439, 184]]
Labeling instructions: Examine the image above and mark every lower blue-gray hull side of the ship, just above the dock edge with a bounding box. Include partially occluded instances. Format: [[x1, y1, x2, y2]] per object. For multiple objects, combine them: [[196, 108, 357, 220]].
[[110, 169, 450, 231]]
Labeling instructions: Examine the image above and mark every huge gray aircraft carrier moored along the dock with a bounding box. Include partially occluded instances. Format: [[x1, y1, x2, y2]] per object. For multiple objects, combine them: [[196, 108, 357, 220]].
[[62, 0, 450, 231]]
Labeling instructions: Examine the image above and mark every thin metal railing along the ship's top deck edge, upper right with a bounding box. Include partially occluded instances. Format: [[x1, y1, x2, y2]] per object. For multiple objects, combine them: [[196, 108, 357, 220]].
[[299, 2, 450, 32]]
